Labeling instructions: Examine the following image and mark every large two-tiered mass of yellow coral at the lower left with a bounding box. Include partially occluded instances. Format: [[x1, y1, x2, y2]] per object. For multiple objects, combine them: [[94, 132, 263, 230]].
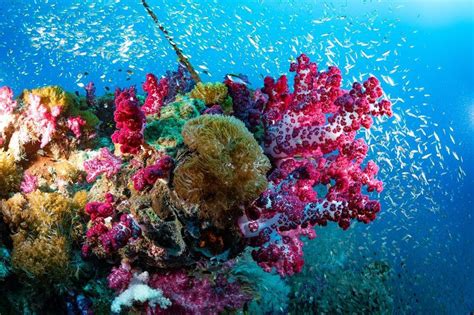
[[1, 191, 76, 281]]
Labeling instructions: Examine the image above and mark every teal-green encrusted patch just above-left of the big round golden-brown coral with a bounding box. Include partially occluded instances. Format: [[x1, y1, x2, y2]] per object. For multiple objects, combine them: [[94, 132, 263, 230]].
[[145, 97, 205, 156]]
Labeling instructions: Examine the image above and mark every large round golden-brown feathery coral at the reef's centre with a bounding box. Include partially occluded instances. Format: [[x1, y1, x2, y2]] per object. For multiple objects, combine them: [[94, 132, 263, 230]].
[[173, 115, 270, 227]]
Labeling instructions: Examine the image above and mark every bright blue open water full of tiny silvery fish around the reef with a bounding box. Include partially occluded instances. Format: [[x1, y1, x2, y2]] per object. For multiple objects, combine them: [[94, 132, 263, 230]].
[[0, 0, 474, 314]]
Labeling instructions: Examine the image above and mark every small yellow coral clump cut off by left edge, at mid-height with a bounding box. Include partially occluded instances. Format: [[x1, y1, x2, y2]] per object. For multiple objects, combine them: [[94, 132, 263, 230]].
[[0, 150, 21, 198]]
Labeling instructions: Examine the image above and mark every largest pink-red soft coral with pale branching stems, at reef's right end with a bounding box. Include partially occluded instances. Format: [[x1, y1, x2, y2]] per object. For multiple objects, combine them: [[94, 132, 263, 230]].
[[239, 55, 391, 276]]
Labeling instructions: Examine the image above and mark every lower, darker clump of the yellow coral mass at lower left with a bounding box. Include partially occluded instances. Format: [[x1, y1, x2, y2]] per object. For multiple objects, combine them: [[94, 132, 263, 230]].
[[12, 232, 70, 280]]
